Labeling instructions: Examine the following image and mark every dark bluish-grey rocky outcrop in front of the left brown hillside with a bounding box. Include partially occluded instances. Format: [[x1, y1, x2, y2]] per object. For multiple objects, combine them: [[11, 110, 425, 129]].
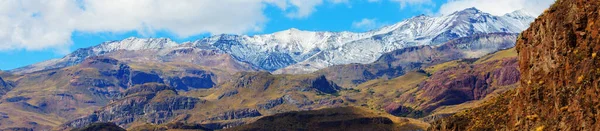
[[65, 83, 203, 128]]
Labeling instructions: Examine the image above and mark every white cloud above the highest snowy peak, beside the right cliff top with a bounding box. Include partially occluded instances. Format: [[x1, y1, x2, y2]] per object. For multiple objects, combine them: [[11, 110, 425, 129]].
[[439, 0, 554, 15]]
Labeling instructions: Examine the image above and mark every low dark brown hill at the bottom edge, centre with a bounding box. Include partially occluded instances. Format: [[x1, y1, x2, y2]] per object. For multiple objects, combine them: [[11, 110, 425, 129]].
[[226, 107, 423, 131]]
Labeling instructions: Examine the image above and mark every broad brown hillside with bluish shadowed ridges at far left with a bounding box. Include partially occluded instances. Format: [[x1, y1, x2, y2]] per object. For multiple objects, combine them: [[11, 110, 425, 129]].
[[0, 56, 240, 130]]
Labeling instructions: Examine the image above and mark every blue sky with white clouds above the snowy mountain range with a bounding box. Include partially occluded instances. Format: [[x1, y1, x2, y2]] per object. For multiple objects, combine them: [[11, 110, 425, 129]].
[[0, 0, 552, 70]]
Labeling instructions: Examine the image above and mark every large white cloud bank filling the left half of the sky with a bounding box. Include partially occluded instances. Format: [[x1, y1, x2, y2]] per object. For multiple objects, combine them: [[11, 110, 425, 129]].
[[0, 0, 346, 52]]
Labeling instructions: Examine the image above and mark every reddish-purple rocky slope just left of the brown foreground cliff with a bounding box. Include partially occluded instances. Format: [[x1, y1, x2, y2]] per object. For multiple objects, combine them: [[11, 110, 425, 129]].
[[420, 58, 519, 112]]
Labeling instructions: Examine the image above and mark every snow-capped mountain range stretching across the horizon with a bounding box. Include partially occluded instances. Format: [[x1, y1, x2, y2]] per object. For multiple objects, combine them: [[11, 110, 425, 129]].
[[11, 8, 534, 73]]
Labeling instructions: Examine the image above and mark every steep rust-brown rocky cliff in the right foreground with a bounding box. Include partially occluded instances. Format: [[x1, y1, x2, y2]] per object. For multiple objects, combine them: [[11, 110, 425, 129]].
[[432, 0, 600, 130]]
